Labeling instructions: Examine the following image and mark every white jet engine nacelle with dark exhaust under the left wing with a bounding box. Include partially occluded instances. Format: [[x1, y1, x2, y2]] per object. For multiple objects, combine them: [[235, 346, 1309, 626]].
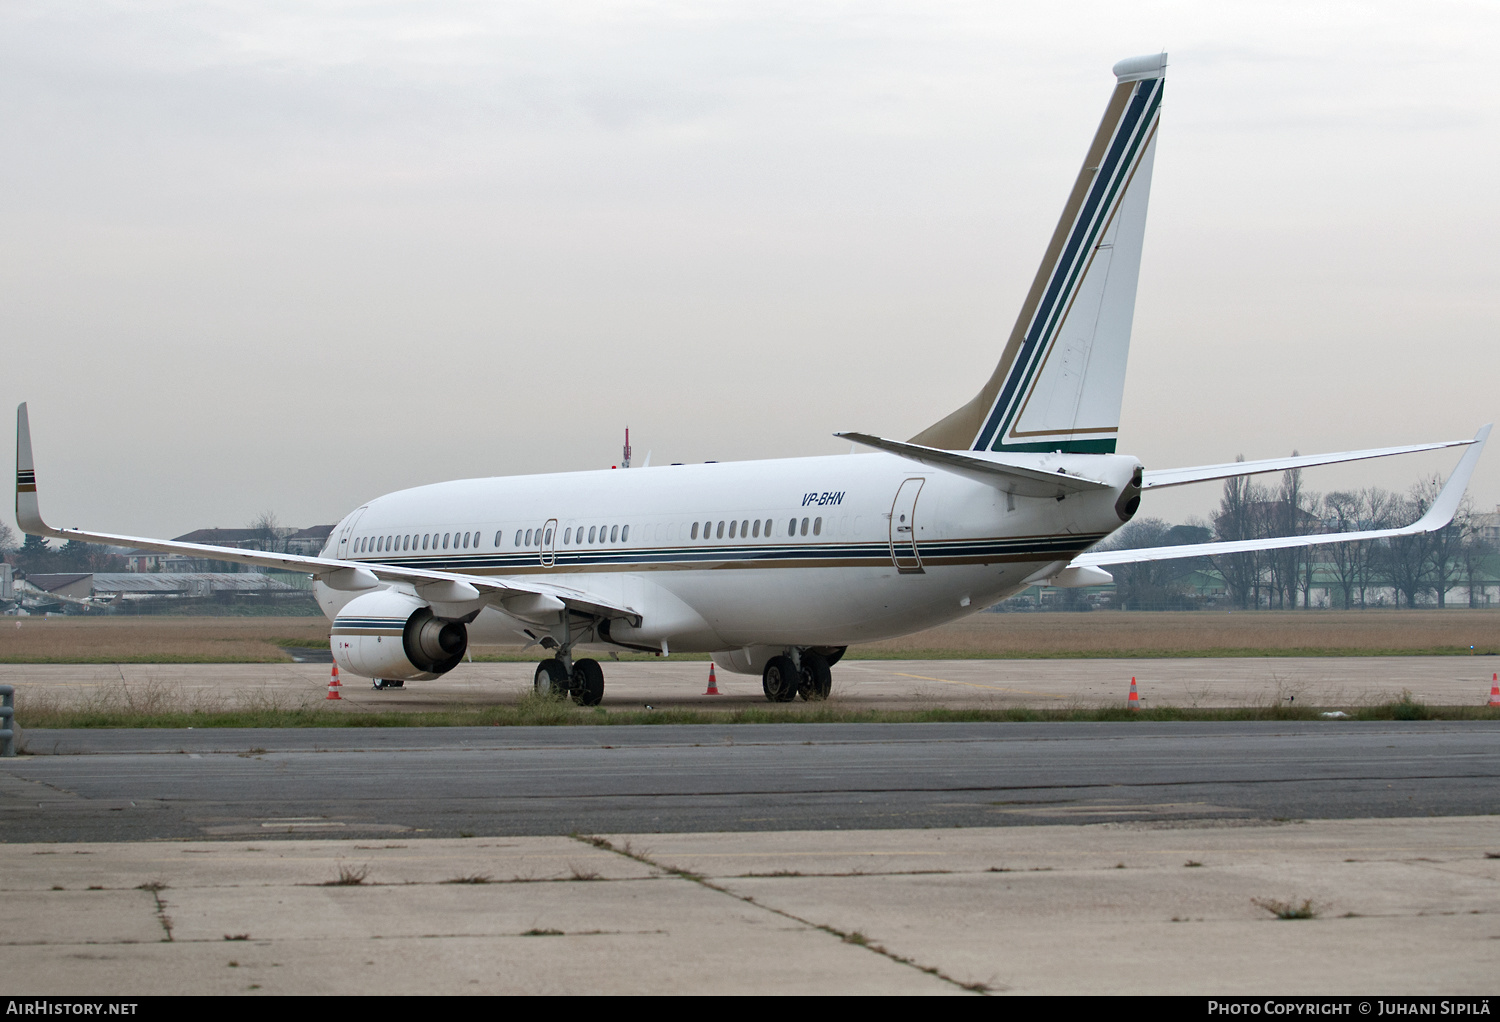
[[330, 590, 468, 681]]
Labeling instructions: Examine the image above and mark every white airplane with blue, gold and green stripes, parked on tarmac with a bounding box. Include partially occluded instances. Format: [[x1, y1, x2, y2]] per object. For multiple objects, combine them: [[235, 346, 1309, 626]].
[[17, 54, 1490, 705]]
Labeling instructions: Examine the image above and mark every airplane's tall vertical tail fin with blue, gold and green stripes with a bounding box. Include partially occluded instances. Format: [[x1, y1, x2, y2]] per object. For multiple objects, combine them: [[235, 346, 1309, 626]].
[[912, 54, 1167, 453]]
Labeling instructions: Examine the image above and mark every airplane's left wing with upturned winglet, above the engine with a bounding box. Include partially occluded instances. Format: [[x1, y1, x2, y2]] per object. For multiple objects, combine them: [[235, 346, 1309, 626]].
[[15, 402, 641, 624]]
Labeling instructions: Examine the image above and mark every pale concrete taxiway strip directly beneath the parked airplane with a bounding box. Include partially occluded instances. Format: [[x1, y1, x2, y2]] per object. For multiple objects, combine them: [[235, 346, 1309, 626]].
[[0, 656, 1500, 708]]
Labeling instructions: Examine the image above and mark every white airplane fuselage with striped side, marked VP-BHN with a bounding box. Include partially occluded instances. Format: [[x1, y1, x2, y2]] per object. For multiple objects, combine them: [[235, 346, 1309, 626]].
[[317, 453, 1139, 669]]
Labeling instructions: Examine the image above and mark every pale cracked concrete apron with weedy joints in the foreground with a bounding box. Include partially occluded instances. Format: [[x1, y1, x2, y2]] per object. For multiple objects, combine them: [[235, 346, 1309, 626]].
[[0, 816, 1500, 995]]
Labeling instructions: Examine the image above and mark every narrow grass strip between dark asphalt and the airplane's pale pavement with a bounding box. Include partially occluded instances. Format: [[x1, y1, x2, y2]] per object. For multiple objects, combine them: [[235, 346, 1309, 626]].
[[18, 695, 1500, 729]]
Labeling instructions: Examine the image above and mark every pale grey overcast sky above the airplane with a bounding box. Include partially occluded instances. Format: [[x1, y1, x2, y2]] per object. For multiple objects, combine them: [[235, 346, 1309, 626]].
[[0, 0, 1500, 536]]
